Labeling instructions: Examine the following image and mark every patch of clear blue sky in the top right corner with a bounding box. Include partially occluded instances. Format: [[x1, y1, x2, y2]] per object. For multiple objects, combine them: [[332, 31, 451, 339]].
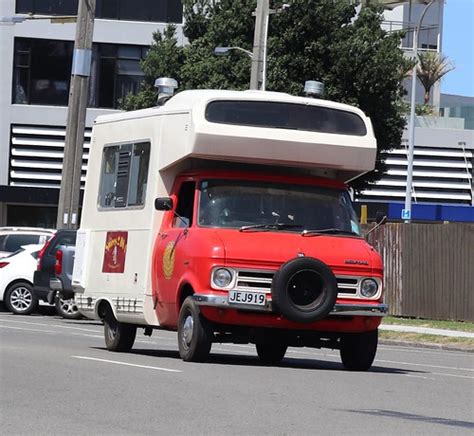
[[441, 0, 474, 97]]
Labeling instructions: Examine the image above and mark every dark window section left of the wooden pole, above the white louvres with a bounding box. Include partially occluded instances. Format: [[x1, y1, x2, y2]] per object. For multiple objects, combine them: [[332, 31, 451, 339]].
[[12, 38, 73, 106]]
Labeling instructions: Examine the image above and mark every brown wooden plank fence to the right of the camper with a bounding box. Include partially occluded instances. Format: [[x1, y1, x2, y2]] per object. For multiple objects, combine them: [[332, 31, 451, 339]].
[[369, 223, 474, 321]]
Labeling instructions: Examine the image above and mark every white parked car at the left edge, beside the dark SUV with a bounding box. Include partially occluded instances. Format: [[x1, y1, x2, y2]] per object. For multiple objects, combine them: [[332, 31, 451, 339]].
[[0, 244, 44, 315]]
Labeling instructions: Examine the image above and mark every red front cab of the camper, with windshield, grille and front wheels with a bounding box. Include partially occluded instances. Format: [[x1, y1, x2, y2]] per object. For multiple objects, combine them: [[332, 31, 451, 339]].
[[152, 171, 387, 369]]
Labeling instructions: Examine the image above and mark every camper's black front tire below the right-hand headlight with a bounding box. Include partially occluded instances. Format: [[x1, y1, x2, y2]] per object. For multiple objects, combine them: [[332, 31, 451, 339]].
[[340, 330, 379, 371]]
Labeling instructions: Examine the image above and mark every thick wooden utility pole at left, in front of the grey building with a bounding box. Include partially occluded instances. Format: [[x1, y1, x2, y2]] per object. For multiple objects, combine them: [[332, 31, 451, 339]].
[[57, 0, 96, 229]]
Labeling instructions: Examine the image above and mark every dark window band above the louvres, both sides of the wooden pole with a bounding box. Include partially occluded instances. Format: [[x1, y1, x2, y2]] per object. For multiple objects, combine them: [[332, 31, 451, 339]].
[[12, 38, 148, 108]]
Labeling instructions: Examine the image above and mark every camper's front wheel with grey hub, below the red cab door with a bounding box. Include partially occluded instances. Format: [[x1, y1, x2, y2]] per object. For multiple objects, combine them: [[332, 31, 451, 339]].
[[178, 297, 213, 362]]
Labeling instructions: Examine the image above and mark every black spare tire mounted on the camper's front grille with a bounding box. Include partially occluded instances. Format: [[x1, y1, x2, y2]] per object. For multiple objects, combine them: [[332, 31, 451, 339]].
[[272, 257, 337, 323]]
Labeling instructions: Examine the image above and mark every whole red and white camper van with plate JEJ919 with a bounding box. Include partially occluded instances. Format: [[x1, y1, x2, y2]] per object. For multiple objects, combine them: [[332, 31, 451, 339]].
[[73, 86, 387, 370]]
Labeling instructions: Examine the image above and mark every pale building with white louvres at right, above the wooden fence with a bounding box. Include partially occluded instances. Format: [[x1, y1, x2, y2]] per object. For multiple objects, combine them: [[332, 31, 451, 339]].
[[358, 0, 474, 220]]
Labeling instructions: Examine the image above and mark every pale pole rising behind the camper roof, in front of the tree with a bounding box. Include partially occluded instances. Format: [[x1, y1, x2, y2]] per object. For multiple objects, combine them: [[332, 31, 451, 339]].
[[250, 0, 270, 90]]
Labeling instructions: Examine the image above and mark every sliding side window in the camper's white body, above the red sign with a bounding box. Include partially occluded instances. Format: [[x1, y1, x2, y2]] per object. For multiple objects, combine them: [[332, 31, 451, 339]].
[[98, 142, 150, 209]]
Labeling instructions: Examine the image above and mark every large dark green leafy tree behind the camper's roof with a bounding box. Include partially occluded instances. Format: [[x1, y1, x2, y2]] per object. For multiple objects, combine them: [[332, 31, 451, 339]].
[[124, 0, 412, 189]]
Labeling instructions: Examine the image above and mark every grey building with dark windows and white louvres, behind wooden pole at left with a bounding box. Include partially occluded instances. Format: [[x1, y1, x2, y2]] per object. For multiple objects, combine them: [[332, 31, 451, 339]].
[[0, 0, 184, 227]]
